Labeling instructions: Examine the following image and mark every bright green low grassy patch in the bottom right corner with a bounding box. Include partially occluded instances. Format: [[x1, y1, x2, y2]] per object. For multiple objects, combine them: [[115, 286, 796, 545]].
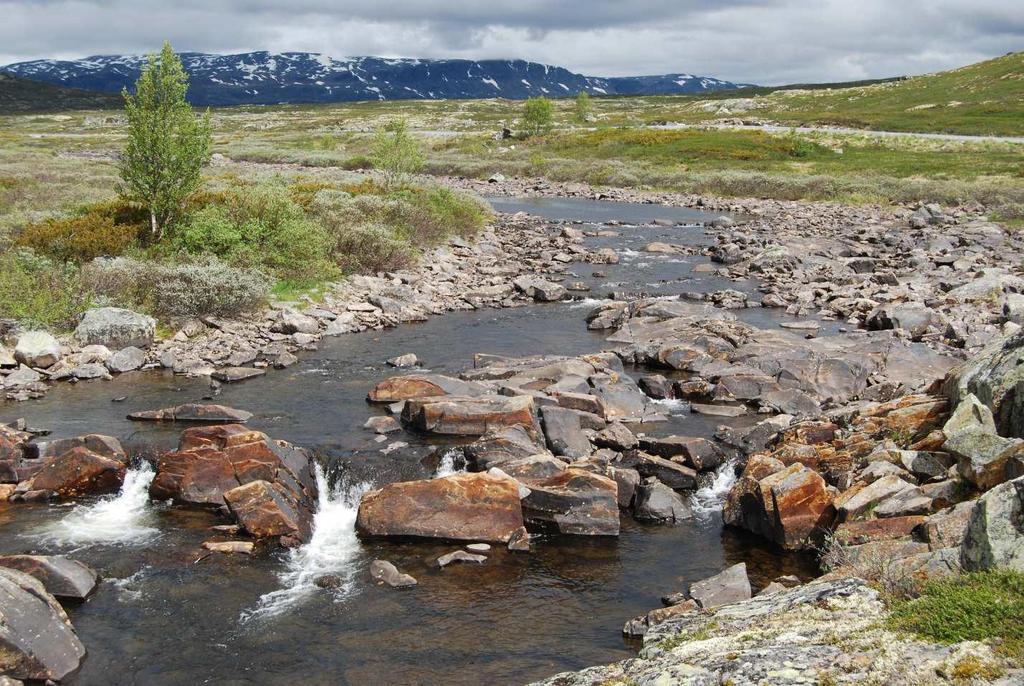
[[889, 570, 1024, 664]]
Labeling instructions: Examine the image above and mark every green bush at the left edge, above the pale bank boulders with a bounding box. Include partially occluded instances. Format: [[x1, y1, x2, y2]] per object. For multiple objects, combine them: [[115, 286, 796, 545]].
[[0, 248, 92, 330]]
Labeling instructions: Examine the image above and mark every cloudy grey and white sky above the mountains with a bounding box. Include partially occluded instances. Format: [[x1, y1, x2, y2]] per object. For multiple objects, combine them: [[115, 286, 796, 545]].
[[0, 0, 1024, 84]]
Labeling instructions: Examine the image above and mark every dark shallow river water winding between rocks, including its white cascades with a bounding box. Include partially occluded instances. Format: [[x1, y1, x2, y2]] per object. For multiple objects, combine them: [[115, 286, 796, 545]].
[[0, 199, 827, 686]]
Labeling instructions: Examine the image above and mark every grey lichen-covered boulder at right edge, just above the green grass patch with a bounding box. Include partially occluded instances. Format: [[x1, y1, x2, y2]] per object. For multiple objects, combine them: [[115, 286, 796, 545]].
[[961, 477, 1024, 571]]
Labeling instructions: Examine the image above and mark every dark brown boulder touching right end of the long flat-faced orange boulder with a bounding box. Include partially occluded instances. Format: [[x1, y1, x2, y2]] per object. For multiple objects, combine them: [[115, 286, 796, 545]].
[[522, 467, 618, 535]]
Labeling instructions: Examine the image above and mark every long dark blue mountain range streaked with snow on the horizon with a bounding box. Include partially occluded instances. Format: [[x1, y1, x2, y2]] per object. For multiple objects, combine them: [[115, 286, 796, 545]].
[[0, 52, 753, 105]]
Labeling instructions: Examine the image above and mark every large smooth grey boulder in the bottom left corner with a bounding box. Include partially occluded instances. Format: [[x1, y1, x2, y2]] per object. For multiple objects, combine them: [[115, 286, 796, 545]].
[[0, 568, 85, 682]]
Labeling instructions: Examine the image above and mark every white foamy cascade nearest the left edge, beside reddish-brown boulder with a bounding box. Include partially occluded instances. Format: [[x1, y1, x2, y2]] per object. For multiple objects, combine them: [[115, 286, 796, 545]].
[[35, 462, 160, 549]]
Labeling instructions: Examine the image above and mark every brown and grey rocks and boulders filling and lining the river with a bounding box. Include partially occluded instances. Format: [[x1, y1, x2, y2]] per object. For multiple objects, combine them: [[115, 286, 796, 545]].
[[0, 185, 1024, 684]]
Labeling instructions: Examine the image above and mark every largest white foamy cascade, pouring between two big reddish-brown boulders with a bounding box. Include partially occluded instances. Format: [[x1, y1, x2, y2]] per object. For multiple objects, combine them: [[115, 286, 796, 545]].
[[241, 465, 371, 621]]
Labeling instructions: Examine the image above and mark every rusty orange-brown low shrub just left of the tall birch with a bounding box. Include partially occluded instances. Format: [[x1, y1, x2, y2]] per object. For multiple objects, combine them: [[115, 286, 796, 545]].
[[15, 200, 146, 262]]
